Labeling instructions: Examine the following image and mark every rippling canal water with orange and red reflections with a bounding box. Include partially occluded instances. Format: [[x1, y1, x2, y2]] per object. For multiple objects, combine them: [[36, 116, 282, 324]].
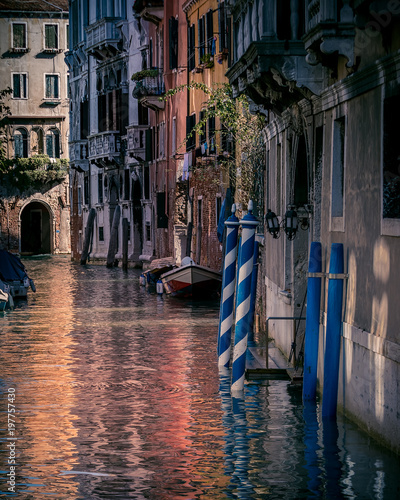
[[0, 256, 400, 500]]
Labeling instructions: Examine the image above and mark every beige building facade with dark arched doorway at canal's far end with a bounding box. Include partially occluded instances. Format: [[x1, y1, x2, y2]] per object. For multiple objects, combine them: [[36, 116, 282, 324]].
[[0, 0, 70, 254]]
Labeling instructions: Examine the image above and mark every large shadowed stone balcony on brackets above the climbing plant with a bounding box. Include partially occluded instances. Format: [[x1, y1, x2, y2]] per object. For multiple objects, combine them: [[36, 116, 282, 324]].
[[226, 0, 324, 113]]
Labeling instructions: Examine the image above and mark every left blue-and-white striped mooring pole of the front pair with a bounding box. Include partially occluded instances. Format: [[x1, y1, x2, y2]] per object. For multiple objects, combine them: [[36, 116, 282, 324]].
[[218, 204, 239, 368]]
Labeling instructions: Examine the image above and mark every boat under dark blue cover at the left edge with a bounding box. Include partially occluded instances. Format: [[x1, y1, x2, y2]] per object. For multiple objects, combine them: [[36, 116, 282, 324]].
[[0, 250, 36, 299]]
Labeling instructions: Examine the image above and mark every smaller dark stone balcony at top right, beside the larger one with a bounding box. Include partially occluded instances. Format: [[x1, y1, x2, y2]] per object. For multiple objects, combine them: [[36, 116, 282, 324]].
[[303, 0, 355, 68]]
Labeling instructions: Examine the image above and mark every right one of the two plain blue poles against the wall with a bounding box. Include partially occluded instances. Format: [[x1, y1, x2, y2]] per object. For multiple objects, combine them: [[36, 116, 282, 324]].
[[322, 243, 344, 418]]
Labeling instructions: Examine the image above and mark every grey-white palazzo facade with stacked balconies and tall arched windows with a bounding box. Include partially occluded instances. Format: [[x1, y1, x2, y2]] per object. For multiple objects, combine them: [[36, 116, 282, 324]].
[[66, 0, 148, 265]]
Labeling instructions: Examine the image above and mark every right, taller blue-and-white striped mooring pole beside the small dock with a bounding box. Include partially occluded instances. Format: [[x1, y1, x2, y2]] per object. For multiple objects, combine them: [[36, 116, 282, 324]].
[[231, 201, 258, 393]]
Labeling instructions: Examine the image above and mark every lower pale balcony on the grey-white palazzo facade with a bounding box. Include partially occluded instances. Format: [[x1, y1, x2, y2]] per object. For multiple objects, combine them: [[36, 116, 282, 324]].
[[88, 130, 121, 168]]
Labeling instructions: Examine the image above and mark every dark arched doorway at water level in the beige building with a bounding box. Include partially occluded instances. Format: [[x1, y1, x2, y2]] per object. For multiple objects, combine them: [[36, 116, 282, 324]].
[[21, 201, 51, 255]]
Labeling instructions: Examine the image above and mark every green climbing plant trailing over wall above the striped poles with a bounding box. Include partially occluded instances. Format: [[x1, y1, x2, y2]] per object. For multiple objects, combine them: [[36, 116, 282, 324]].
[[161, 82, 265, 212]]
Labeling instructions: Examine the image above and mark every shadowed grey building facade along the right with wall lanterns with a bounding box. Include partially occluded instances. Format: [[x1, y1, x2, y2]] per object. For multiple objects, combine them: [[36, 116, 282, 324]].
[[227, 0, 400, 451]]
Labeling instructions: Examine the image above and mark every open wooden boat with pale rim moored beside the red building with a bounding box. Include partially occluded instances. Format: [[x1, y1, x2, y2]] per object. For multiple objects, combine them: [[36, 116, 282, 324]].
[[161, 257, 222, 299]]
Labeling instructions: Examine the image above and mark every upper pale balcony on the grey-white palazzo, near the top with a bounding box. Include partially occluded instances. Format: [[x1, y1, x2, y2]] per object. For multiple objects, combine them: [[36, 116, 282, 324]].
[[86, 18, 122, 61]]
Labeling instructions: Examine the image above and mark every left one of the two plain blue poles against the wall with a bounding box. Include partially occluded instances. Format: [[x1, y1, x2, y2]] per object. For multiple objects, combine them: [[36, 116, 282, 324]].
[[303, 241, 322, 401]]
